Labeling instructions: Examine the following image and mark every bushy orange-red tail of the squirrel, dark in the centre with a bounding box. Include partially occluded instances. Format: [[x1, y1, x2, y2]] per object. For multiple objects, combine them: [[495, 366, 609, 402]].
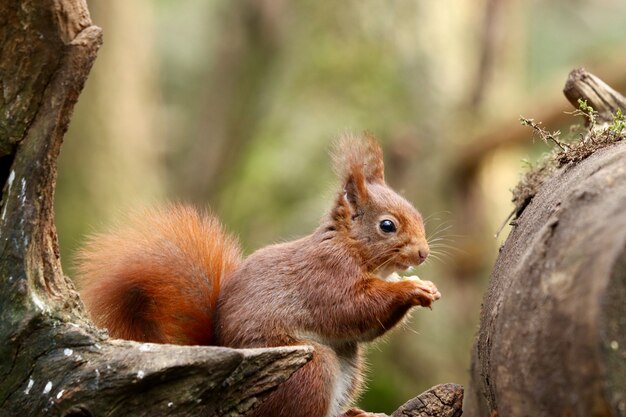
[[76, 205, 241, 345]]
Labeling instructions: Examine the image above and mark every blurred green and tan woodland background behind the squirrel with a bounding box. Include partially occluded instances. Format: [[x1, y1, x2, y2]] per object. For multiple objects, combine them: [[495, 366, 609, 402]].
[[56, 0, 626, 412]]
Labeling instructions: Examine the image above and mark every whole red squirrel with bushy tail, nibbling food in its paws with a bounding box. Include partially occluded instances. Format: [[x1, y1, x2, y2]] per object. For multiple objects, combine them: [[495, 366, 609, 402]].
[[77, 135, 440, 417]]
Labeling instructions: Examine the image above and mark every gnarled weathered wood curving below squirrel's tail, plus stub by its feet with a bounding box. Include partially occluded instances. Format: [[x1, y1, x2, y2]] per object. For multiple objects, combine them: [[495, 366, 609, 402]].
[[0, 0, 463, 417]]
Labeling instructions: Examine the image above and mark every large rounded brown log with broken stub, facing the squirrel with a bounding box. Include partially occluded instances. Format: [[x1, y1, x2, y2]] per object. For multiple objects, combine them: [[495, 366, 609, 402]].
[[465, 69, 626, 417]]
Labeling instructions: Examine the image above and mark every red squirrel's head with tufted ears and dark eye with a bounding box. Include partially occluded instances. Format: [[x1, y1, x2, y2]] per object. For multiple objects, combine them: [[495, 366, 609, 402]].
[[331, 134, 429, 276]]
